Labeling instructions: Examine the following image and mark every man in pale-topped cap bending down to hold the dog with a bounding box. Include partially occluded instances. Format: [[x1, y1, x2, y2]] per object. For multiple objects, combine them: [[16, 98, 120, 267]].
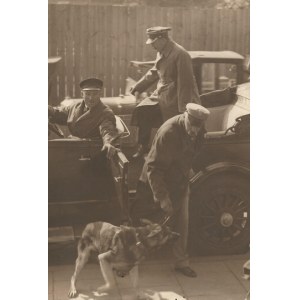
[[132, 103, 209, 277]]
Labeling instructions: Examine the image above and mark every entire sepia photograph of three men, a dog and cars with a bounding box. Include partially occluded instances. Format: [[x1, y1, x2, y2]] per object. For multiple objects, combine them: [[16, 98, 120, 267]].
[[48, 0, 250, 300]]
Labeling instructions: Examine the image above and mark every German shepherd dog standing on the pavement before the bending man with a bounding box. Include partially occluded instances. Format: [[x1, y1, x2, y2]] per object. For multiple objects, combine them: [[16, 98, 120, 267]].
[[69, 219, 179, 297]]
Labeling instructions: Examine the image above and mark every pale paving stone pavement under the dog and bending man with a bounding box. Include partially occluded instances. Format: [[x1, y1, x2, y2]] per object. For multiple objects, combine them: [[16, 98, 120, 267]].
[[48, 253, 250, 300]]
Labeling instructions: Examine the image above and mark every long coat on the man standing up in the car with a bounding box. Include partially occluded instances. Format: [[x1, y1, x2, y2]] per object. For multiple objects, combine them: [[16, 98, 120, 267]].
[[132, 40, 199, 120]]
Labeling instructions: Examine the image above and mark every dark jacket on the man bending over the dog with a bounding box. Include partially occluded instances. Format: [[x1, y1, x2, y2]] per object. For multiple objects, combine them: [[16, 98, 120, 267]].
[[140, 114, 205, 203]]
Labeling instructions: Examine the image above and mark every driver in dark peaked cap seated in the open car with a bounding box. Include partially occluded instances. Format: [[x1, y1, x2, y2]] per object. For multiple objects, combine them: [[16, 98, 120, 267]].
[[48, 78, 118, 159]]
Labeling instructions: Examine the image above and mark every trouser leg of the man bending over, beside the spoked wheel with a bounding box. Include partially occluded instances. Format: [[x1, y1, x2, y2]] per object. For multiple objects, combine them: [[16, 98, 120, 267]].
[[173, 186, 190, 267]]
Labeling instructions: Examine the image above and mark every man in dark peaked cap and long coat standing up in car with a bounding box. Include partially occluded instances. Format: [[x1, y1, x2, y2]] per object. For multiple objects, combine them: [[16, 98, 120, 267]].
[[131, 26, 199, 158]]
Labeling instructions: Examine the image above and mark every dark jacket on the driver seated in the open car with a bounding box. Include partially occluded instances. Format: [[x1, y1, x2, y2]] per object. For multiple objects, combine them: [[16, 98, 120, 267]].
[[50, 100, 118, 143]]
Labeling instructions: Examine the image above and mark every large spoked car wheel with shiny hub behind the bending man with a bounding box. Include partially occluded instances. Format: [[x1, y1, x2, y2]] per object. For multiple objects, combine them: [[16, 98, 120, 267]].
[[189, 174, 250, 255]]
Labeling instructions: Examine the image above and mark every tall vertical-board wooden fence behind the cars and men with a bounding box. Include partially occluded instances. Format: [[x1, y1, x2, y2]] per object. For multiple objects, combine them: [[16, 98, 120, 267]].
[[48, 4, 250, 104]]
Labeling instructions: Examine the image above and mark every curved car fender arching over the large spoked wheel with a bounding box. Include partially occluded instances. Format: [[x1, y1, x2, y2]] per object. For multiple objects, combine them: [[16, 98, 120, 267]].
[[190, 161, 250, 189]]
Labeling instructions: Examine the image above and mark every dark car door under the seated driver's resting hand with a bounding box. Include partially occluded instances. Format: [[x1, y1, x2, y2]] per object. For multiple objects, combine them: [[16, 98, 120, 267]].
[[48, 139, 128, 226]]
